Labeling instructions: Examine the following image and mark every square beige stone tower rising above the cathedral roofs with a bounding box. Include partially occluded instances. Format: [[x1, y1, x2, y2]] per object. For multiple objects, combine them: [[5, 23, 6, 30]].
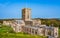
[[22, 8, 31, 21]]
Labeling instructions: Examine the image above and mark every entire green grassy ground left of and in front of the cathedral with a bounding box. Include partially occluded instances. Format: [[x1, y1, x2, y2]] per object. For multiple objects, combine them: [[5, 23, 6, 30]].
[[0, 25, 46, 38]]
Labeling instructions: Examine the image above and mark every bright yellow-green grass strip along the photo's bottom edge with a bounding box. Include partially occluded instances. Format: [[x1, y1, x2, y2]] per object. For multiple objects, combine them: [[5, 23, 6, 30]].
[[0, 33, 45, 38]]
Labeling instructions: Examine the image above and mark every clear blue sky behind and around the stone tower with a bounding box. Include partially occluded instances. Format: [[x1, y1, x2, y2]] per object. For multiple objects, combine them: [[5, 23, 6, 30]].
[[0, 0, 60, 19]]
